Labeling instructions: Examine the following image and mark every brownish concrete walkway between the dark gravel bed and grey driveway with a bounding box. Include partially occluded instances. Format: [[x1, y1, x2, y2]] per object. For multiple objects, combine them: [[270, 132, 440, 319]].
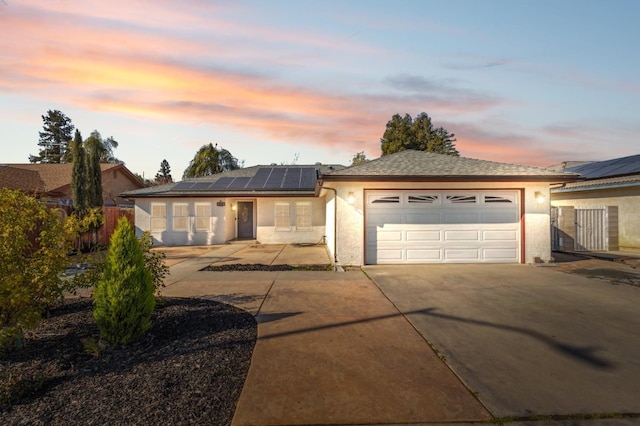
[[163, 245, 492, 425]]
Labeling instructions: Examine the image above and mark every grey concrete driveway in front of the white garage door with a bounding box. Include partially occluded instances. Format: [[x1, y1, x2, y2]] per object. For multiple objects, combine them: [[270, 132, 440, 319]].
[[364, 265, 640, 420]]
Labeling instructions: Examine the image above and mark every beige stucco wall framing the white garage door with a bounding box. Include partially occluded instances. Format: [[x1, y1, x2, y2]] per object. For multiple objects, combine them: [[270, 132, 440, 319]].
[[321, 182, 551, 265]]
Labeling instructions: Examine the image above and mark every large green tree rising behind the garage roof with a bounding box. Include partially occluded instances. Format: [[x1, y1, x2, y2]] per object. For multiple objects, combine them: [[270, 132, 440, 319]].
[[380, 112, 460, 156]]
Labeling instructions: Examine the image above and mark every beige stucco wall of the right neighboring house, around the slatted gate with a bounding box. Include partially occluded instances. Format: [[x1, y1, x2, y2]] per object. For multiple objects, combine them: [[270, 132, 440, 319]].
[[551, 187, 640, 251]]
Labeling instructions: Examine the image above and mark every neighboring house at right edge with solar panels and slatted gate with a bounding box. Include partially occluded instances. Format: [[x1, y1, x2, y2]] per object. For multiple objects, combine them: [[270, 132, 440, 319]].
[[551, 155, 640, 251]]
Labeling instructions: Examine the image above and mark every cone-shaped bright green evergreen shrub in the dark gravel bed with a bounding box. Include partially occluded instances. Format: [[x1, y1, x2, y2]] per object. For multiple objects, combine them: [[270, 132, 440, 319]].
[[93, 218, 155, 345]]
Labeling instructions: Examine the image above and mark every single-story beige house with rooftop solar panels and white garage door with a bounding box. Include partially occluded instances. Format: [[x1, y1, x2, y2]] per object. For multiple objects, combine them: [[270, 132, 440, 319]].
[[122, 151, 577, 265]]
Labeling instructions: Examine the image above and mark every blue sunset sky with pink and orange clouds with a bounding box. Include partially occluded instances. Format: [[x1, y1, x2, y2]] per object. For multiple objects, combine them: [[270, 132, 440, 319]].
[[0, 0, 640, 179]]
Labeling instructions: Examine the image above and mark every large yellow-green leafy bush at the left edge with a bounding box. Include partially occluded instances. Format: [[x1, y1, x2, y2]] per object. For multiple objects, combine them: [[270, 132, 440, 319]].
[[0, 188, 74, 348]]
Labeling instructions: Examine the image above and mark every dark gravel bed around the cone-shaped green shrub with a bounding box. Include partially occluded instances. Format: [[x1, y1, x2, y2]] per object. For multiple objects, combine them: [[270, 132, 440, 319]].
[[0, 299, 257, 425]]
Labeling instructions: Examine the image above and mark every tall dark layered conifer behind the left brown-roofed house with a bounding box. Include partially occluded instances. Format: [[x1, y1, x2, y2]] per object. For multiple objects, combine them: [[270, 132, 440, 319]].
[[29, 109, 74, 163]]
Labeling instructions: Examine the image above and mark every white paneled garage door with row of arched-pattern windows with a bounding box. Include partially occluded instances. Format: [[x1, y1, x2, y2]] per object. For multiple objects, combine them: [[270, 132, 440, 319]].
[[365, 190, 520, 264]]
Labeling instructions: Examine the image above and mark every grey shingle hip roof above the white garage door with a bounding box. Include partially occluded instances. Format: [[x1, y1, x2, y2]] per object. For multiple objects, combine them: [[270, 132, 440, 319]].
[[323, 150, 578, 180]]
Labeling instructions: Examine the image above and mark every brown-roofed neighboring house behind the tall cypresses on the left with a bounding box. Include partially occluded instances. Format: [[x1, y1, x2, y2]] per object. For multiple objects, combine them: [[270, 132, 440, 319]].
[[0, 163, 144, 206]]
